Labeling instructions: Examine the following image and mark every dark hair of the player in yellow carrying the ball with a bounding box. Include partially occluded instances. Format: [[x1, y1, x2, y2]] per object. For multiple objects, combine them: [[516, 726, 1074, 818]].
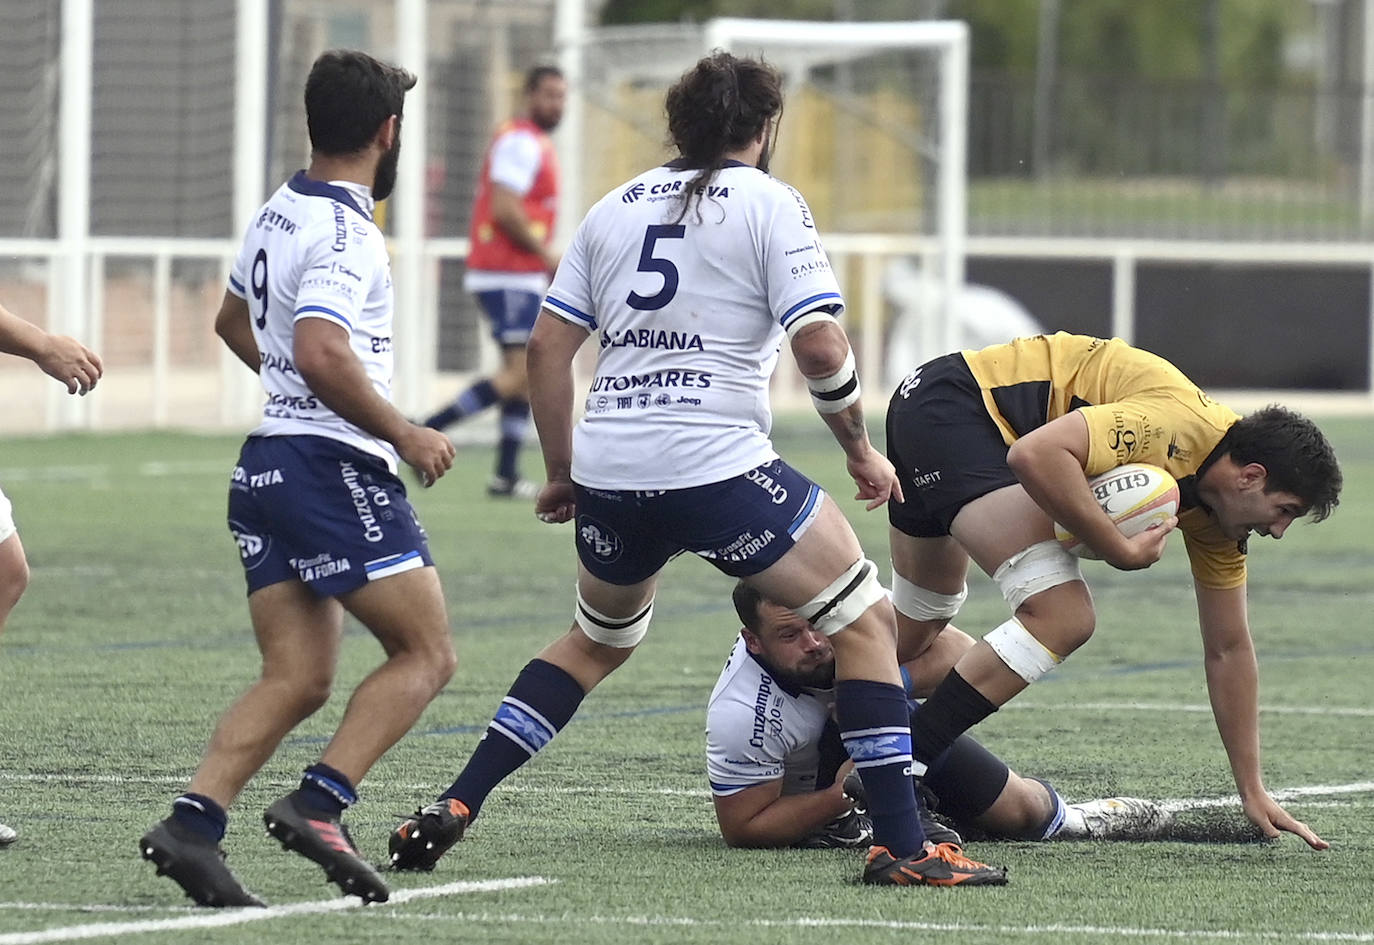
[[1217, 404, 1342, 522]]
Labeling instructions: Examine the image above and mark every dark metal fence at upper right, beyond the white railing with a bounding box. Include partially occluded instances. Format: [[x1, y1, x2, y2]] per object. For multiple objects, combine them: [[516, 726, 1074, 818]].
[[969, 73, 1374, 240]]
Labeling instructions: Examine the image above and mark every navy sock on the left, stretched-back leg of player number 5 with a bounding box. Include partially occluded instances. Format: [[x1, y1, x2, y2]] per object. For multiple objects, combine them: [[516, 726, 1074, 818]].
[[440, 659, 587, 819]]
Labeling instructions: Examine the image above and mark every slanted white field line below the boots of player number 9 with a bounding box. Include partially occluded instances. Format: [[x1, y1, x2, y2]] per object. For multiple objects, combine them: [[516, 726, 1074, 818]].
[[0, 876, 554, 945]]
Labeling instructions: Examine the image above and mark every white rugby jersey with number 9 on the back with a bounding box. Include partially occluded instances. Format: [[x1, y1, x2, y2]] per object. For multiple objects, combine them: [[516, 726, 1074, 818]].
[[229, 170, 397, 473]]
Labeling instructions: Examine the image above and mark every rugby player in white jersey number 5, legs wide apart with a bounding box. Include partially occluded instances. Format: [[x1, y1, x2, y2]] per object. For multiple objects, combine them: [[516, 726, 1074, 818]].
[[392, 52, 1006, 886]]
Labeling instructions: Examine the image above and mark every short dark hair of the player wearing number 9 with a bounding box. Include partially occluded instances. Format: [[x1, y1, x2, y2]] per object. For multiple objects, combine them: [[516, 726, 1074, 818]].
[[305, 49, 415, 155]]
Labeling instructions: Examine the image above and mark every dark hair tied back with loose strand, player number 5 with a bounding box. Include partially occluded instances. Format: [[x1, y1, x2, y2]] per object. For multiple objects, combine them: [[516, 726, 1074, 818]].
[[664, 49, 782, 220]]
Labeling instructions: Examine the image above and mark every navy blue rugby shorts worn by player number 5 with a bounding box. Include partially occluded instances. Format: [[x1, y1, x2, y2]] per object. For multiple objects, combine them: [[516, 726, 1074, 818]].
[[574, 459, 826, 585]]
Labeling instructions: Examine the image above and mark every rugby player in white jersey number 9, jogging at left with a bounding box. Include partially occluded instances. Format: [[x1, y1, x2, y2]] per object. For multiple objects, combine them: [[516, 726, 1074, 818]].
[[139, 51, 455, 907]]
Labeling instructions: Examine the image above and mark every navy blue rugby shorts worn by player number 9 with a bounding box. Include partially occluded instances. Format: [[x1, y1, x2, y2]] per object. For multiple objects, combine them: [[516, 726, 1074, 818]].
[[228, 437, 434, 597]]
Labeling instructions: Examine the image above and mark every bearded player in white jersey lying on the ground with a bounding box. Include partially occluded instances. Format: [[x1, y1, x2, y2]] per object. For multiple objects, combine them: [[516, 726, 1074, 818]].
[[706, 582, 1172, 847]]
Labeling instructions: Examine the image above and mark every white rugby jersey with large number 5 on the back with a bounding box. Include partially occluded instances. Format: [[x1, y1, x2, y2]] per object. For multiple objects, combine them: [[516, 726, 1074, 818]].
[[544, 162, 844, 489]]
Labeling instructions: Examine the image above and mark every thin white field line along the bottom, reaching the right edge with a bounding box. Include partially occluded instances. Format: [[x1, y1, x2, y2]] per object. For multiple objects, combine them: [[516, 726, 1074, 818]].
[[370, 912, 1374, 942]]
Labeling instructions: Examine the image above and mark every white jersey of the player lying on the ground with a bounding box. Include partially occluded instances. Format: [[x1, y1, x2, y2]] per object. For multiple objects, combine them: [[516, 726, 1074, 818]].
[[706, 636, 834, 797]]
